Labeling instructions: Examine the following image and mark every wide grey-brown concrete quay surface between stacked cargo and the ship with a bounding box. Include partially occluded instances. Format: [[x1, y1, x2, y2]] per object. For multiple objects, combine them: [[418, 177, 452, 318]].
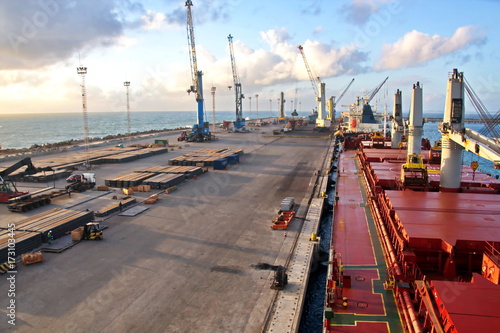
[[0, 125, 330, 332]]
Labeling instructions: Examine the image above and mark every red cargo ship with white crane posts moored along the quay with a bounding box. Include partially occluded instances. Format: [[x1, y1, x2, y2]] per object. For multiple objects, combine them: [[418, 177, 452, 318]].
[[323, 69, 500, 333]]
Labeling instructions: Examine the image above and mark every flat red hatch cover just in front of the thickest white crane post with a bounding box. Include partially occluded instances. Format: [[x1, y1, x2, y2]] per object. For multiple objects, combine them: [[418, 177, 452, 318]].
[[385, 191, 500, 247]]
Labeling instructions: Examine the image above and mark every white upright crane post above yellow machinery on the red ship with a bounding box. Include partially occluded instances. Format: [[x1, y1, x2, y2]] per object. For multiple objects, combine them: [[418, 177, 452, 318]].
[[408, 82, 424, 155]]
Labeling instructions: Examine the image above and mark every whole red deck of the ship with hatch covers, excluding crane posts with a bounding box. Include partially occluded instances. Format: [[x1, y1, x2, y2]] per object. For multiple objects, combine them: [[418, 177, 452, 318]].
[[332, 145, 500, 332]]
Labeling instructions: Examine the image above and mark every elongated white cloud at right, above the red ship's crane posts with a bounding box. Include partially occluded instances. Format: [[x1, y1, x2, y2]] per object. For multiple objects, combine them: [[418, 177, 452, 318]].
[[375, 26, 485, 70]]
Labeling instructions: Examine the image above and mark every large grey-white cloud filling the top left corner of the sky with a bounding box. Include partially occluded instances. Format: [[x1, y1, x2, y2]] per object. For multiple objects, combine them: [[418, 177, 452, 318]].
[[0, 0, 144, 69]]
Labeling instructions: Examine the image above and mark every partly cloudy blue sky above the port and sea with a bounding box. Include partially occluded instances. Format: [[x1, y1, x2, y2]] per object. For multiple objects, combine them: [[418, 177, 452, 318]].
[[0, 0, 500, 117]]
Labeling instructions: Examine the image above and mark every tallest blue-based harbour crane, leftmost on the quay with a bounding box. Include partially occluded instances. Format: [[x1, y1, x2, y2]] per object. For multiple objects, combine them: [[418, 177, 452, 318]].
[[186, 0, 212, 142]]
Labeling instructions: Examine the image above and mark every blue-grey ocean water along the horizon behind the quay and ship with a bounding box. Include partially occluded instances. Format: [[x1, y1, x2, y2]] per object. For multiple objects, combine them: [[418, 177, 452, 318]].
[[0, 110, 500, 177]]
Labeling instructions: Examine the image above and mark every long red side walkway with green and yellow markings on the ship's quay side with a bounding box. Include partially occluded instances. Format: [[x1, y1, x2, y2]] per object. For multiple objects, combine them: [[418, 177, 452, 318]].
[[327, 151, 402, 333]]
